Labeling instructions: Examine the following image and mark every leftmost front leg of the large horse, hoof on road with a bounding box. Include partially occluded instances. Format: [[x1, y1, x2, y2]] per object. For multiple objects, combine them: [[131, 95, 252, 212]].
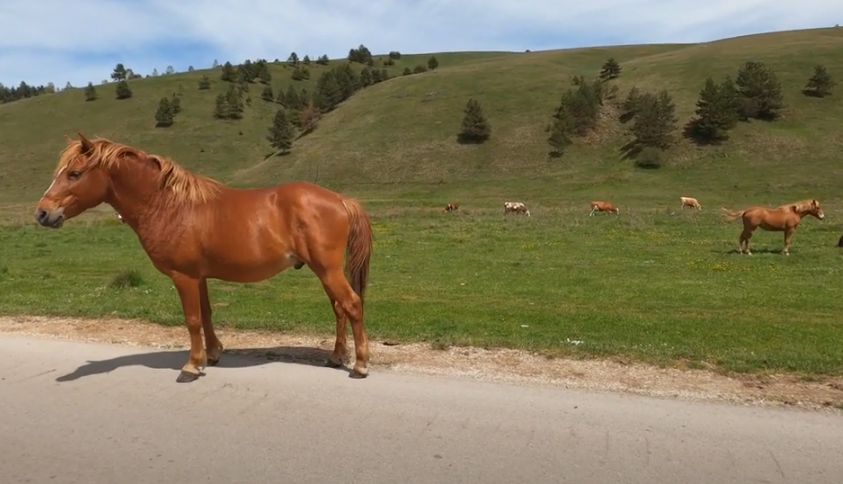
[[170, 273, 208, 383]]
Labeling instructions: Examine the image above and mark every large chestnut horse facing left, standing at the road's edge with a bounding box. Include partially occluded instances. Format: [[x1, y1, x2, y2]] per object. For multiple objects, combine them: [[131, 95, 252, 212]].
[[35, 133, 372, 382]]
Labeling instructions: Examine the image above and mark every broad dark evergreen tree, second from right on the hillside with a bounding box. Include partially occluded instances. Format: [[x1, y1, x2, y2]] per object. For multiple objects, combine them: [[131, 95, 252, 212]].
[[735, 61, 784, 120]]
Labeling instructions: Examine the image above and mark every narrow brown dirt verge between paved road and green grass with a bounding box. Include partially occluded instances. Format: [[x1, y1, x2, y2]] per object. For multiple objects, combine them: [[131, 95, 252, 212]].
[[0, 316, 843, 408]]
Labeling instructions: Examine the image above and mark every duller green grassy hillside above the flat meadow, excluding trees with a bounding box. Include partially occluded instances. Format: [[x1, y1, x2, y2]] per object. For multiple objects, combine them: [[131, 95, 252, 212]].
[[0, 28, 843, 203]]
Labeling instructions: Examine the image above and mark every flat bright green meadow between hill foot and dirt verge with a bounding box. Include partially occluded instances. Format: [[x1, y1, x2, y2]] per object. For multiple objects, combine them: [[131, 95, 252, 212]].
[[0, 203, 843, 374]]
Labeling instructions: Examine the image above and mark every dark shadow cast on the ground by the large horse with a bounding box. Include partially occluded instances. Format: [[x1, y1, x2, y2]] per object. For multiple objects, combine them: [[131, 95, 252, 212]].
[[55, 346, 351, 382]]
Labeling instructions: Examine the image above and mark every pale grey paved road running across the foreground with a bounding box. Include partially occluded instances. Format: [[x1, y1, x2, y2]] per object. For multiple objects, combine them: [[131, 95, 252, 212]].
[[0, 335, 843, 484]]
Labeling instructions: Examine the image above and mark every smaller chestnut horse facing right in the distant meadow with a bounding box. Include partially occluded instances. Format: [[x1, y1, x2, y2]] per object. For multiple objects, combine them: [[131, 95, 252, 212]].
[[722, 199, 825, 255]]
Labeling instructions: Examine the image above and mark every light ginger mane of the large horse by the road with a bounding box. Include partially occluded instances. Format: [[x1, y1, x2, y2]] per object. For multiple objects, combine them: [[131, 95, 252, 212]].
[[54, 138, 223, 203]]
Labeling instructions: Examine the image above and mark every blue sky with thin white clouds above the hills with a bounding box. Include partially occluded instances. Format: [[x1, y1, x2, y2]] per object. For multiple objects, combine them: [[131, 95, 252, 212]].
[[0, 0, 843, 88]]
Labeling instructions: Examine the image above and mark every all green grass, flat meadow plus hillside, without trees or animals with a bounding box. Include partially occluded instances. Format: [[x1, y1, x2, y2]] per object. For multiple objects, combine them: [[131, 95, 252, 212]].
[[0, 29, 843, 375]]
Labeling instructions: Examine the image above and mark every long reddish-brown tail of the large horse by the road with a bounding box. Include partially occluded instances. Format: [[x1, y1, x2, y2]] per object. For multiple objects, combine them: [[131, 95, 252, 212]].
[[343, 198, 372, 303]]
